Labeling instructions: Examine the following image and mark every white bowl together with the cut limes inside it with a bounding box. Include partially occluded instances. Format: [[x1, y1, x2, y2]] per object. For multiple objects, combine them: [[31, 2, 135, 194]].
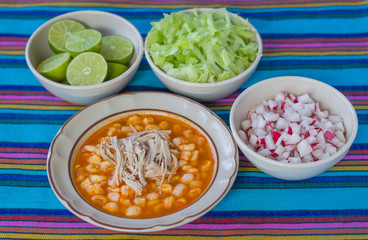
[[25, 11, 143, 105]]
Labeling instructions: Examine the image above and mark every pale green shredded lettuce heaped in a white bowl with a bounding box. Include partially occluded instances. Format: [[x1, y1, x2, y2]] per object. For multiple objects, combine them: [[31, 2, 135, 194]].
[[146, 8, 258, 83]]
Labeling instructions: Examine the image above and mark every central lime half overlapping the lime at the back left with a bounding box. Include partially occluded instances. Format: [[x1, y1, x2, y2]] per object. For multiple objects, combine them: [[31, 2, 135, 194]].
[[65, 29, 102, 57]]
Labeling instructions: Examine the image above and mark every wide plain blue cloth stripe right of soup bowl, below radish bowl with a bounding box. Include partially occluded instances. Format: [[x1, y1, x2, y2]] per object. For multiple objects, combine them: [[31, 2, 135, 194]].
[[214, 188, 368, 211]]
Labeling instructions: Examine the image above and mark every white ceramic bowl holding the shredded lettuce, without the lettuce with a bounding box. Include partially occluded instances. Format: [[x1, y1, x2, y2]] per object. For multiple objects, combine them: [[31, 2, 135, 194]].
[[145, 8, 263, 102]]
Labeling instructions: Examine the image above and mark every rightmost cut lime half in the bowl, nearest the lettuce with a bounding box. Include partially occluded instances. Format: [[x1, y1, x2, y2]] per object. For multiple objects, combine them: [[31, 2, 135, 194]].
[[100, 36, 134, 64]]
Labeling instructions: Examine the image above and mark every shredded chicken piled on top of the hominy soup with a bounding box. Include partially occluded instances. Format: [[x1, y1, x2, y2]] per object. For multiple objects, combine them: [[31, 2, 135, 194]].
[[101, 129, 178, 195]]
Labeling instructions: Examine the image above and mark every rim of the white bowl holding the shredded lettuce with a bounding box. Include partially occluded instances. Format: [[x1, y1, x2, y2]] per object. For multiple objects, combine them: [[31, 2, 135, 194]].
[[144, 8, 263, 88]]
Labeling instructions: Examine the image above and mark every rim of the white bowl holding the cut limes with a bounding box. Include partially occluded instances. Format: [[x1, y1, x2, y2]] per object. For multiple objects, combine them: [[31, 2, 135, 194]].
[[25, 10, 144, 90]]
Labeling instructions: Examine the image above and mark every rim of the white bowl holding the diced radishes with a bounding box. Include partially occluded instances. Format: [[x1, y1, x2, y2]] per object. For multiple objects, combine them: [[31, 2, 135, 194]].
[[230, 76, 358, 169]]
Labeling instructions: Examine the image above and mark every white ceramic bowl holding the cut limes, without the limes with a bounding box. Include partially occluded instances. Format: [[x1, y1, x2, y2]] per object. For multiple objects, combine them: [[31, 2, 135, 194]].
[[25, 11, 143, 104]]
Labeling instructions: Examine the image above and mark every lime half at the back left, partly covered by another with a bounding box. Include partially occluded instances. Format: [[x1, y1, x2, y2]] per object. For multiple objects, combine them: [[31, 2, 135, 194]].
[[48, 19, 84, 53]]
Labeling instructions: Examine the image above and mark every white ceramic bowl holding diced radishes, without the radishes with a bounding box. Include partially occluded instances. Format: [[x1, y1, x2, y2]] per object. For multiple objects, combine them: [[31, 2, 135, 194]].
[[230, 76, 358, 180]]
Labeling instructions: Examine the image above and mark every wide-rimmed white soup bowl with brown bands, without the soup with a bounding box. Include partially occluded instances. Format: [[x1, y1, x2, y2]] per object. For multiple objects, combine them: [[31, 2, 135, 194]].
[[47, 92, 239, 232]]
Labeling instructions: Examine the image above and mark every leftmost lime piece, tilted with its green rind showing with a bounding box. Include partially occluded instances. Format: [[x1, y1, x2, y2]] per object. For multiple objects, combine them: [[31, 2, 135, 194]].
[[37, 53, 72, 82]]
